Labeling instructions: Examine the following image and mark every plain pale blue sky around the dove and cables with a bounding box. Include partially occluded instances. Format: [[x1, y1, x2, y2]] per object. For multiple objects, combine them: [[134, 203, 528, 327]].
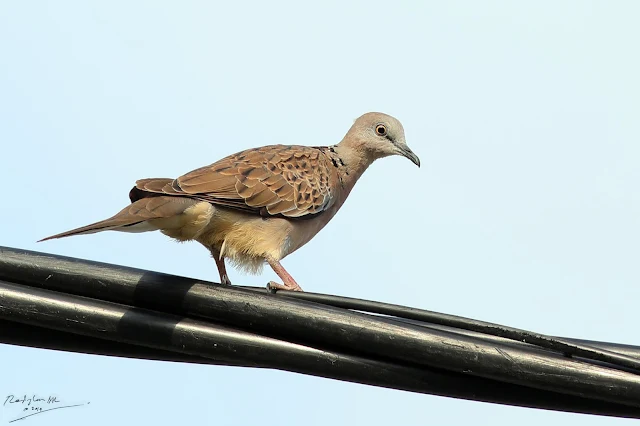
[[0, 0, 640, 426]]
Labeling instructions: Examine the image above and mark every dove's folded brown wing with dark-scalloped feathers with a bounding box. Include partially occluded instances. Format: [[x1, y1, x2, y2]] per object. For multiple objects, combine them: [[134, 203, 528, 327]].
[[130, 145, 340, 218]]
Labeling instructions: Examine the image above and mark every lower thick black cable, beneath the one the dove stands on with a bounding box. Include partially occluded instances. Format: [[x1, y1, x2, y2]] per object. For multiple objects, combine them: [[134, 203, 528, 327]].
[[0, 281, 640, 418]]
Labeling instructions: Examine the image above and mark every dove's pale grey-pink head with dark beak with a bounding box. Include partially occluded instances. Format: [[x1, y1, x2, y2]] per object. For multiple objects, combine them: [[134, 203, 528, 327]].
[[343, 112, 420, 167]]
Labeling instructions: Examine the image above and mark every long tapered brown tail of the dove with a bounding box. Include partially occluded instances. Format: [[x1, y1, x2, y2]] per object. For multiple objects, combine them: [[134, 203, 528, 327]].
[[38, 196, 197, 242]]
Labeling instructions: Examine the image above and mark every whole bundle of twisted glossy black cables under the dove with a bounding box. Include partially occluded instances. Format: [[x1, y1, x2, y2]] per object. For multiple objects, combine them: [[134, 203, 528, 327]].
[[0, 247, 640, 418]]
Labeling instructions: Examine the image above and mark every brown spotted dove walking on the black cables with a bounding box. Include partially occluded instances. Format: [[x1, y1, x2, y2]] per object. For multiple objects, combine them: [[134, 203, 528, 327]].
[[40, 112, 420, 291]]
